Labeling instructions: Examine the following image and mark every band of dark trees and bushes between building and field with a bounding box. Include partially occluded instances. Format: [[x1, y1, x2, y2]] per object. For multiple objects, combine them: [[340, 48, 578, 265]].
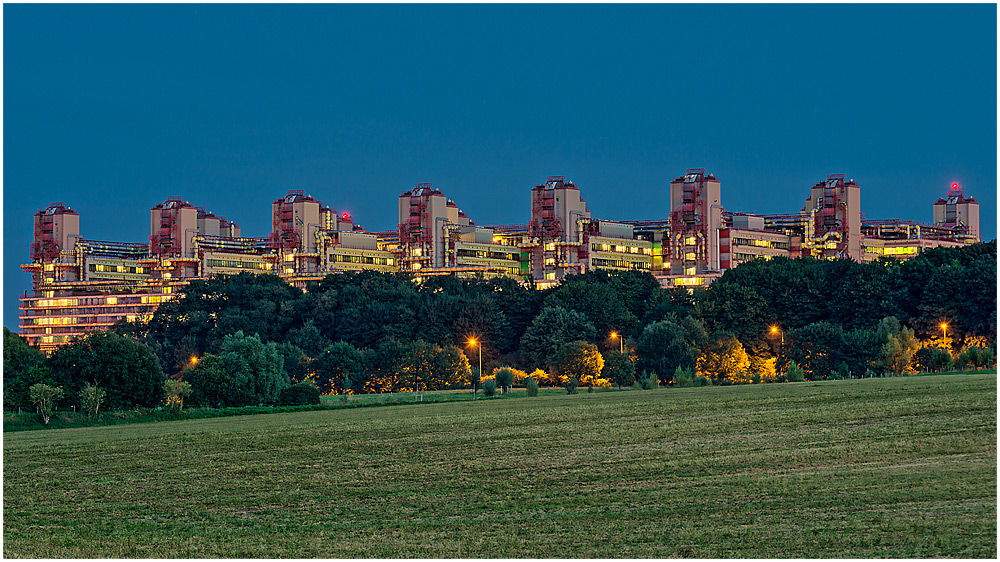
[[4, 241, 996, 409]]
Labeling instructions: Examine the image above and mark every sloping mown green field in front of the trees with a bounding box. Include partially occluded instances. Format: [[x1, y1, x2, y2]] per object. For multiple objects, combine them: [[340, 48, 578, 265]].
[[3, 375, 997, 558]]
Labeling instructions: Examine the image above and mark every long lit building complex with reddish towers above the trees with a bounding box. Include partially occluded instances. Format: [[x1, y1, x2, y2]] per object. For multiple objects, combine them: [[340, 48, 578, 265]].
[[19, 168, 980, 351]]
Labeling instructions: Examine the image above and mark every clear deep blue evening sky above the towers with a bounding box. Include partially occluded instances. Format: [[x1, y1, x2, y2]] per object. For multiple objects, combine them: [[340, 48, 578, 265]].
[[3, 4, 997, 327]]
